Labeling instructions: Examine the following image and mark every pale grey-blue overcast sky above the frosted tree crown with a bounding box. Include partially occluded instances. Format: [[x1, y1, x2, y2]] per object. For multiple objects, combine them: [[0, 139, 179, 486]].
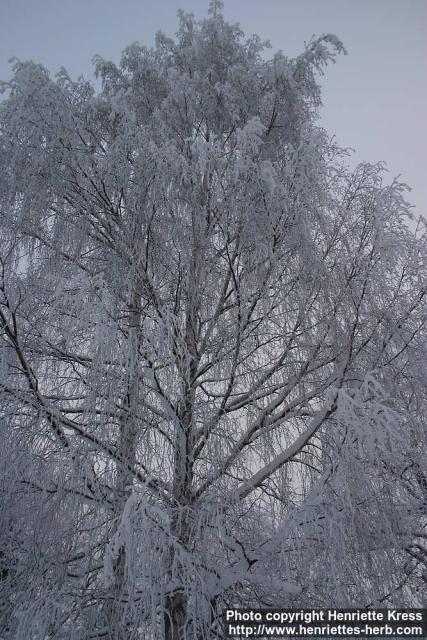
[[0, 0, 427, 215]]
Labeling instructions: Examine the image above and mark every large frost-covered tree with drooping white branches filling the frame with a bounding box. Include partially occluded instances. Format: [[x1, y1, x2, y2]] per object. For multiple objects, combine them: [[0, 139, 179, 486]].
[[0, 1, 427, 640]]
